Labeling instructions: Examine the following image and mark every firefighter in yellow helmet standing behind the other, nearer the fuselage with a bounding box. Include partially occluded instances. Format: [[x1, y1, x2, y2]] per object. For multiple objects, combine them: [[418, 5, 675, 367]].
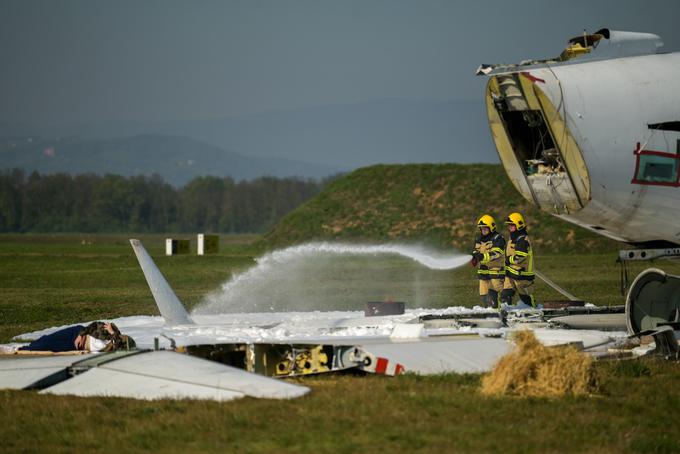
[[501, 213, 536, 308]]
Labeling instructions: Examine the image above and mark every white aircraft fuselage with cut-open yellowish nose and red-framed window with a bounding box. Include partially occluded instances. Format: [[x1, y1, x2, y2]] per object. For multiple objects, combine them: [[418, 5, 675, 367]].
[[486, 31, 680, 245]]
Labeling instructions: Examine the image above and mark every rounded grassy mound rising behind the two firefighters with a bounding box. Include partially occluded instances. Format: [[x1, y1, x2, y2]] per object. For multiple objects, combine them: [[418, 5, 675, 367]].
[[266, 164, 615, 252]]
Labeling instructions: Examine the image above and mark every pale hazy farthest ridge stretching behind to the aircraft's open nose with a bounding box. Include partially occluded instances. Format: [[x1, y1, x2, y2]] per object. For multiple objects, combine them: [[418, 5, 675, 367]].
[[18, 100, 498, 170]]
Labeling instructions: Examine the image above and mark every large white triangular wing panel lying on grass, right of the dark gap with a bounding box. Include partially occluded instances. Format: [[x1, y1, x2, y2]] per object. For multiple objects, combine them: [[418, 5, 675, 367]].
[[41, 351, 309, 401]]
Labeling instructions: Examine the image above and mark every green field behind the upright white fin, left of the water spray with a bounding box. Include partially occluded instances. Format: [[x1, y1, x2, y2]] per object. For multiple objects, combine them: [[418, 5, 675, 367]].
[[0, 234, 262, 342]]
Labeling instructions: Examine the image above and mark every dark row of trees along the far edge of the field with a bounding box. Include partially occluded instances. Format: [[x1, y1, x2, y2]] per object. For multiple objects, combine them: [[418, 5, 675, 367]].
[[0, 169, 328, 233]]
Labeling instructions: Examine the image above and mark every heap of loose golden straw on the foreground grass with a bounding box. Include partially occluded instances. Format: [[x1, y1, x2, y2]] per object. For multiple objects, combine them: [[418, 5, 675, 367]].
[[482, 330, 598, 397]]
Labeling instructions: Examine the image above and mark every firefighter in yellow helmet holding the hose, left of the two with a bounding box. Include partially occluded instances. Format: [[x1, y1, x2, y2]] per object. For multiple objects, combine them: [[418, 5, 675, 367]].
[[471, 214, 505, 307]]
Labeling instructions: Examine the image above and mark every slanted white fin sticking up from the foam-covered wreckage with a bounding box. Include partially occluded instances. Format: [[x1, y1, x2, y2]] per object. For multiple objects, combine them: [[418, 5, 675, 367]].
[[130, 239, 193, 325]]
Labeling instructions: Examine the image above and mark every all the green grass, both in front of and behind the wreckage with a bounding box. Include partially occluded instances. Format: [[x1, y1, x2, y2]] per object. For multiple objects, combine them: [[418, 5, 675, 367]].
[[0, 234, 680, 452]]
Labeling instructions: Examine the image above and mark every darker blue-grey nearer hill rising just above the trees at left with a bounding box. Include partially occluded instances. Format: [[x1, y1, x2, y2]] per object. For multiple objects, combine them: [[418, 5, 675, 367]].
[[0, 134, 343, 186]]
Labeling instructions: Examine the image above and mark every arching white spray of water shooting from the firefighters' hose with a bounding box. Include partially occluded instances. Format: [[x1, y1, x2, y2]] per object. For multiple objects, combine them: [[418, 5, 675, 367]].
[[194, 243, 469, 314]]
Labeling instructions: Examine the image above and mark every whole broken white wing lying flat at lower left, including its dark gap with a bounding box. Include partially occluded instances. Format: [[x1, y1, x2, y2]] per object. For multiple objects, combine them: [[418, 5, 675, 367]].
[[0, 351, 309, 401]]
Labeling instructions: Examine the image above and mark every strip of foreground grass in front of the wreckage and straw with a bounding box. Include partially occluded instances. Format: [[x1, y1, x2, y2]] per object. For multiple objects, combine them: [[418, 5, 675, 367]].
[[0, 360, 680, 453]]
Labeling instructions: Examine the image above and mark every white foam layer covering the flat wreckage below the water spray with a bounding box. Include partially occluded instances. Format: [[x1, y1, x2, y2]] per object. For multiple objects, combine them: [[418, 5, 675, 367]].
[[13, 306, 627, 354]]
